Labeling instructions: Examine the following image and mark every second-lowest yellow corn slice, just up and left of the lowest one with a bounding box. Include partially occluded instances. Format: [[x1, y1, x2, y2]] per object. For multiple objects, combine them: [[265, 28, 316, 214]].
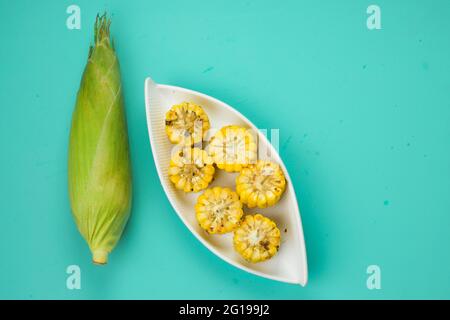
[[195, 187, 243, 234]]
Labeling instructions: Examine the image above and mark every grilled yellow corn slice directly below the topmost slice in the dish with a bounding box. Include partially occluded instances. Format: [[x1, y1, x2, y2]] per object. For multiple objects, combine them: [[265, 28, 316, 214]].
[[169, 147, 215, 192]]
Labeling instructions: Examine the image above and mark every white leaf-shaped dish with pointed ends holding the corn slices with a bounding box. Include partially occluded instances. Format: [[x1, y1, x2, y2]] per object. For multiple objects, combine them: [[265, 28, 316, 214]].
[[145, 78, 308, 286]]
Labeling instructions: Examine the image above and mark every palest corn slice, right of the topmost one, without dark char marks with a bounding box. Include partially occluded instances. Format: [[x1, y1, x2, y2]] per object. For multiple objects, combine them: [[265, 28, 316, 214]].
[[208, 125, 257, 172]]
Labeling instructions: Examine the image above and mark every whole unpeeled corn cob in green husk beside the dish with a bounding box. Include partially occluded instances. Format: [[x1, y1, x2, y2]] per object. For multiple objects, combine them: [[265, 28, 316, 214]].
[[68, 14, 132, 264]]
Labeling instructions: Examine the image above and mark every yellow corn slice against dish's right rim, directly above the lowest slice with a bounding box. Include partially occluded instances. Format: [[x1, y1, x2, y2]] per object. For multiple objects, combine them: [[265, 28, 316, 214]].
[[236, 160, 286, 208]]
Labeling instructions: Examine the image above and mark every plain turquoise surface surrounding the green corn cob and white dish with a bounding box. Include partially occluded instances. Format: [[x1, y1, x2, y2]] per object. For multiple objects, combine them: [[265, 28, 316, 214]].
[[0, 0, 450, 299]]
